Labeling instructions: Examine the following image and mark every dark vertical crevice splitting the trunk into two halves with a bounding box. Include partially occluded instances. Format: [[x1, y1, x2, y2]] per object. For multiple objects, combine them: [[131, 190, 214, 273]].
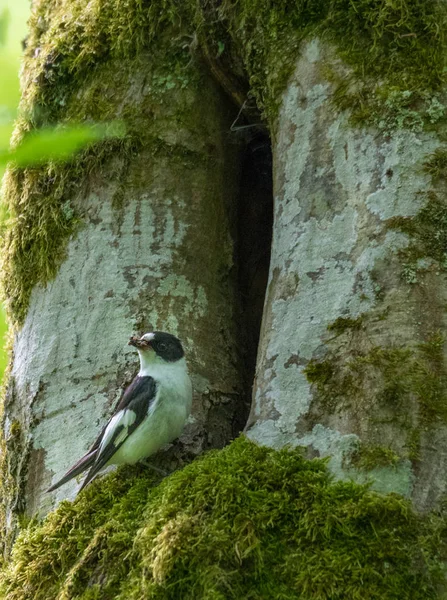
[[202, 51, 273, 437]]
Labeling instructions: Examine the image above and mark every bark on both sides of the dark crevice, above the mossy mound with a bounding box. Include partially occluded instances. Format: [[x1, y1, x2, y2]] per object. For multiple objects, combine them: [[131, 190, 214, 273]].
[[2, 1, 447, 552]]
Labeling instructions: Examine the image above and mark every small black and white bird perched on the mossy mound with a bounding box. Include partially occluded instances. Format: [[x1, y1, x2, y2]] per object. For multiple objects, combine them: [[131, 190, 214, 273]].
[[47, 331, 192, 492]]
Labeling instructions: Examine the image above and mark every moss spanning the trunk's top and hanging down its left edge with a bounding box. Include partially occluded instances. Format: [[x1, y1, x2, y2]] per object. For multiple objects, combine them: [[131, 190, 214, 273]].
[[3, 0, 447, 323]]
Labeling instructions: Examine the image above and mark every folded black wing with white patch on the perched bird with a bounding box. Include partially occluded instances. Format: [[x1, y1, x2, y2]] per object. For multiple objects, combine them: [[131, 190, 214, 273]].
[[79, 376, 157, 491]]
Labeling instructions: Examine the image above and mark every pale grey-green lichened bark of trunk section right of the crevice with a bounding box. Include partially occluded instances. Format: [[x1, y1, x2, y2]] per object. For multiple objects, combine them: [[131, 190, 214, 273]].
[[248, 39, 447, 510]]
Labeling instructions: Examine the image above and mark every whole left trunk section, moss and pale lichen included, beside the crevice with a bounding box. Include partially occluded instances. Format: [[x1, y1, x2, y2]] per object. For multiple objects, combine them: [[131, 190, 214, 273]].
[[3, 3, 245, 533]]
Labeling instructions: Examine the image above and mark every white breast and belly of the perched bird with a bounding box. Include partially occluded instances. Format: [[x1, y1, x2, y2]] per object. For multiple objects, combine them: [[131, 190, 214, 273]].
[[109, 359, 192, 464]]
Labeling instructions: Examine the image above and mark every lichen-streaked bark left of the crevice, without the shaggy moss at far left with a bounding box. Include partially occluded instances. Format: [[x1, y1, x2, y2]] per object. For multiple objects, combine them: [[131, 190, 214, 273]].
[[5, 50, 242, 515]]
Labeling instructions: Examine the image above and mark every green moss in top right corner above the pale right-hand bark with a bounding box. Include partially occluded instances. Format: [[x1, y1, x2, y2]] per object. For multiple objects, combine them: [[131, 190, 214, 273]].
[[327, 0, 447, 133]]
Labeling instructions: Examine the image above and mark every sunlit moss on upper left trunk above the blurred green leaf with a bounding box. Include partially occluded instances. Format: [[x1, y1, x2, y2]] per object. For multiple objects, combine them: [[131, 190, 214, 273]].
[[18, 0, 201, 127]]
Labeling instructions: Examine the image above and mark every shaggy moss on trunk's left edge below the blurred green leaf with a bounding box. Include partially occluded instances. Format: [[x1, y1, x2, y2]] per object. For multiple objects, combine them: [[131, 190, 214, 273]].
[[1, 139, 142, 324]]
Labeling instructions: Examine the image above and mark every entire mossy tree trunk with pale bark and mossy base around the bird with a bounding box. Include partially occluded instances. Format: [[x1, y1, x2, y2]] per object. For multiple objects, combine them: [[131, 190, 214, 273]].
[[0, 0, 447, 598]]
